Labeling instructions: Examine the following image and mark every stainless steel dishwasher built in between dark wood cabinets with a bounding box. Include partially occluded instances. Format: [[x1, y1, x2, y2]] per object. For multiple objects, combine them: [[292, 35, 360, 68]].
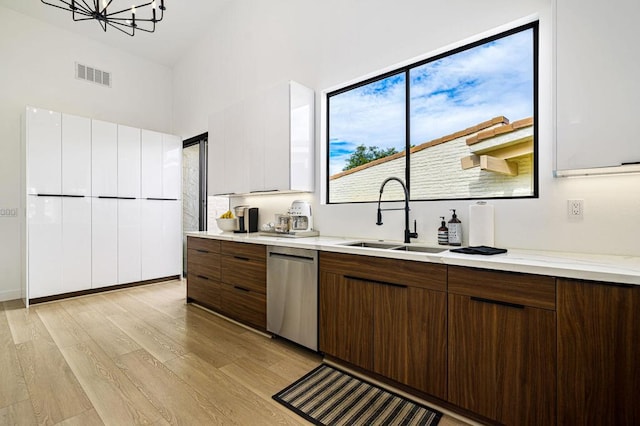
[[267, 246, 318, 351]]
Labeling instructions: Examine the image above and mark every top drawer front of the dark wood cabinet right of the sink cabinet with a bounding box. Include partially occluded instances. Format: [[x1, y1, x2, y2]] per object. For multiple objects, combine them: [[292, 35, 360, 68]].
[[448, 266, 556, 310]]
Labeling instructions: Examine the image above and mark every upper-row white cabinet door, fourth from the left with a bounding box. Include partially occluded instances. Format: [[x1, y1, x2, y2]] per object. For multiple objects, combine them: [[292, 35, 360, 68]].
[[118, 124, 141, 198]]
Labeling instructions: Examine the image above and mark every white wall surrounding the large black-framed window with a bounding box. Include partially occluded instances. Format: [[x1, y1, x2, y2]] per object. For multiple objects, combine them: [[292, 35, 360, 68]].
[[174, 0, 640, 255]]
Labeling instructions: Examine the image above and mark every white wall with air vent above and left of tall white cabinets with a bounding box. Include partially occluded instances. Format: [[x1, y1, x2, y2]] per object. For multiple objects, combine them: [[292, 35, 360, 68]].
[[0, 7, 172, 300]]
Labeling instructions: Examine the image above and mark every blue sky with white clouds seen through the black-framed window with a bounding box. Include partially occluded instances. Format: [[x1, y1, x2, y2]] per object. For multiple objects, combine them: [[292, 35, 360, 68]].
[[329, 29, 533, 175]]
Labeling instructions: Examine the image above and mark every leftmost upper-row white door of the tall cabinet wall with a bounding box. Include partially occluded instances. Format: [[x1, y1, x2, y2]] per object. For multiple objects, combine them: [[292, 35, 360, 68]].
[[26, 107, 62, 194]]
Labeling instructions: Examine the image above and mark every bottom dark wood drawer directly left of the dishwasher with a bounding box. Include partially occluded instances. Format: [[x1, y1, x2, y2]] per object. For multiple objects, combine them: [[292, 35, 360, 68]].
[[220, 284, 267, 330]]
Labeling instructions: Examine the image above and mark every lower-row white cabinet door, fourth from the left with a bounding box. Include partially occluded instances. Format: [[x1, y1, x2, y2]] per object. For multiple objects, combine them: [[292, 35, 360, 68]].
[[118, 200, 142, 284]]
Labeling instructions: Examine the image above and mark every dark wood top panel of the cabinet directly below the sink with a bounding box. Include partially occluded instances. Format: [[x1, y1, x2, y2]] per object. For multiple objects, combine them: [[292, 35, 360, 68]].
[[320, 252, 447, 291]]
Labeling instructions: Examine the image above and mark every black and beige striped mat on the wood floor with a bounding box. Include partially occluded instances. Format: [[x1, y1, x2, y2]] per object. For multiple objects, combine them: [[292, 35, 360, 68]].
[[273, 364, 442, 426]]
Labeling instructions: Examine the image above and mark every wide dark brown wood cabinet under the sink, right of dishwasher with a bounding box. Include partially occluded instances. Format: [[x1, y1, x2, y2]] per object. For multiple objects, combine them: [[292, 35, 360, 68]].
[[320, 252, 446, 398]]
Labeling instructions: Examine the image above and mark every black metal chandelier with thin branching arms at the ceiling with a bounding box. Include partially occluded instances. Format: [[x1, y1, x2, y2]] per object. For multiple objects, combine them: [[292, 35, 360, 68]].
[[41, 0, 166, 37]]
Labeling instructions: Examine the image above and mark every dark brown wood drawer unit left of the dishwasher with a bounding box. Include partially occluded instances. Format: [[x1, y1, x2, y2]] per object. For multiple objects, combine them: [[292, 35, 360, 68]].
[[187, 237, 267, 331]]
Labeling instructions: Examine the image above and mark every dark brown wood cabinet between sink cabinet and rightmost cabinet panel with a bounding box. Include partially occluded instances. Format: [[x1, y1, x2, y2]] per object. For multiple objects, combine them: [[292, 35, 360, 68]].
[[448, 267, 556, 425]]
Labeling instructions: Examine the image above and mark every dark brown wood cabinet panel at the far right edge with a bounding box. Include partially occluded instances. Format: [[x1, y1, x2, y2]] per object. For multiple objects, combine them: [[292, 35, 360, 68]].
[[558, 279, 640, 425]]
